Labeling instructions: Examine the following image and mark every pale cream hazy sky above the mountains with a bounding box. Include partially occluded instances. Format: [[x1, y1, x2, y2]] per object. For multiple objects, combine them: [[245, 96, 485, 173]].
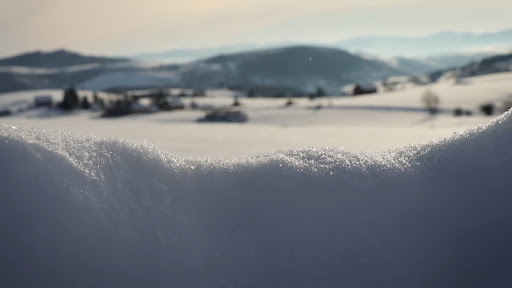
[[0, 0, 512, 56]]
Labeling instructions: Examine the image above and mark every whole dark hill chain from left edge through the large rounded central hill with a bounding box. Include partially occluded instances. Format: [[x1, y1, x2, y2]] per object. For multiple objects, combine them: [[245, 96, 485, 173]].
[[0, 46, 413, 94]]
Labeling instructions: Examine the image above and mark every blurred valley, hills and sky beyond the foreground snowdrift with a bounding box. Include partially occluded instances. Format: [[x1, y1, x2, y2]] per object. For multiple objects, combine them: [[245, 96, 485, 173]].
[[0, 0, 512, 158]]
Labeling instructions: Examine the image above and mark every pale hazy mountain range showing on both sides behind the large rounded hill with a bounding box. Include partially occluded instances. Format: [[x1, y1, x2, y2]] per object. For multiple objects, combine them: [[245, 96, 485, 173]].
[[128, 29, 512, 69]]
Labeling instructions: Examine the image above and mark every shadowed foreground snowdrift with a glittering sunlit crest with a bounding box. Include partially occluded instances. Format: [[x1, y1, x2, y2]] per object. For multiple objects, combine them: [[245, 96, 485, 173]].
[[0, 112, 512, 287]]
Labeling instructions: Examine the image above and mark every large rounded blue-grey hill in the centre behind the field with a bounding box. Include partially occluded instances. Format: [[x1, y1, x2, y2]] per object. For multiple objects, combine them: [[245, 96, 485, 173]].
[[176, 46, 409, 92]]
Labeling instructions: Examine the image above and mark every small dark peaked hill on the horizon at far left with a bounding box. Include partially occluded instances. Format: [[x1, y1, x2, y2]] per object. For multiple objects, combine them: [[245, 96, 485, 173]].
[[0, 50, 129, 68]]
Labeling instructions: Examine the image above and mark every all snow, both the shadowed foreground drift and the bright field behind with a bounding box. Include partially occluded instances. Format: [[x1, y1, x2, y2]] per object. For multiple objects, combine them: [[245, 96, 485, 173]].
[[0, 73, 512, 287]]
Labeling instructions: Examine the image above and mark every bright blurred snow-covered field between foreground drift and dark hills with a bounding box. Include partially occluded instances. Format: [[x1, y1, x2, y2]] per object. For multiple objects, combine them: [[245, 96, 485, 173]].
[[0, 73, 512, 159]]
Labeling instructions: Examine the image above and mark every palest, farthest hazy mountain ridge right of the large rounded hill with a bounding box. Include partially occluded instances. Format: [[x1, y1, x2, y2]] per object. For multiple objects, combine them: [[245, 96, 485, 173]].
[[338, 29, 512, 57]]
